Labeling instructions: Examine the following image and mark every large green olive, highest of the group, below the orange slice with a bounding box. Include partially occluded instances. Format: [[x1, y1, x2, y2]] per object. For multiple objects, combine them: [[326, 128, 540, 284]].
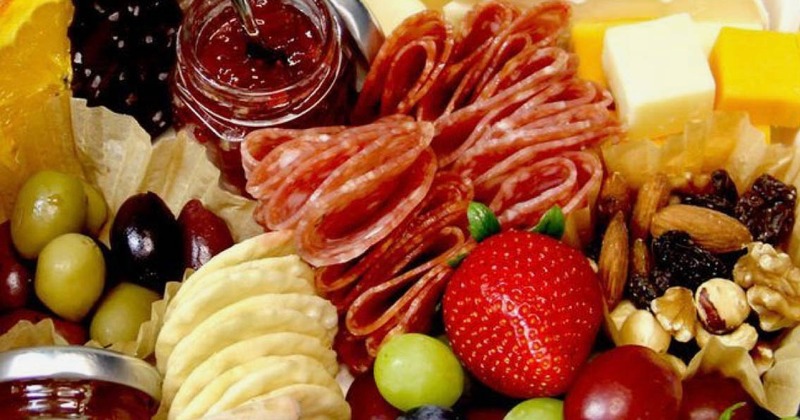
[[11, 171, 87, 259]]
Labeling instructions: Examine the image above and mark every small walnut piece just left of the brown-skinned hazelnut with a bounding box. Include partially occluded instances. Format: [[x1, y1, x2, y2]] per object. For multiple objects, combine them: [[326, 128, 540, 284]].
[[650, 287, 697, 343]]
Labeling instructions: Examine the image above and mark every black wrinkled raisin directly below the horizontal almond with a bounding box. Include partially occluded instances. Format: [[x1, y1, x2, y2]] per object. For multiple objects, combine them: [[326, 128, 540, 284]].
[[652, 231, 728, 290]]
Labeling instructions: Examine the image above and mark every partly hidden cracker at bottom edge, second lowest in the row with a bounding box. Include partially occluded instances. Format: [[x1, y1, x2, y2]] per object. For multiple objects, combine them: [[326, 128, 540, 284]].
[[250, 384, 350, 420]]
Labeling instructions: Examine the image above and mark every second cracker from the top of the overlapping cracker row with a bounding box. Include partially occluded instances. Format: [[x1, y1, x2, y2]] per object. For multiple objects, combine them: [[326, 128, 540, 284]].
[[155, 255, 314, 372]]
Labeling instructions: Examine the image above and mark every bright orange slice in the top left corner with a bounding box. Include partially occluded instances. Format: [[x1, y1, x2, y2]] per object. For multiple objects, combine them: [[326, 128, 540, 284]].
[[0, 0, 81, 220]]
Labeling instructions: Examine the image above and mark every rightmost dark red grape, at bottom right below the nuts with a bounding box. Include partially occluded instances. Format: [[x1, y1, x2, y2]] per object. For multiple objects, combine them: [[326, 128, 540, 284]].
[[679, 374, 755, 420]]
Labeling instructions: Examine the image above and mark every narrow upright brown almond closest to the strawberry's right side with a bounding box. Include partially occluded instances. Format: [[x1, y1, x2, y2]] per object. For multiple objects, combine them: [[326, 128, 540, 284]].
[[597, 212, 629, 310]]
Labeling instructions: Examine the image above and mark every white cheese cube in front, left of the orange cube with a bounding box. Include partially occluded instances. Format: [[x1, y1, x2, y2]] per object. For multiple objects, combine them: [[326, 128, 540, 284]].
[[603, 14, 714, 140]]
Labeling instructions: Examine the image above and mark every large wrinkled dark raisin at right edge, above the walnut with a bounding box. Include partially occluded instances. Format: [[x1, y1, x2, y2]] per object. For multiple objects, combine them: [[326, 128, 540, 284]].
[[736, 175, 797, 245]]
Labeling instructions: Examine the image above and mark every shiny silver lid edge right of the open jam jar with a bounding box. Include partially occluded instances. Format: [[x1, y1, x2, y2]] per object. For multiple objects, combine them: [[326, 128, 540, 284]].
[[328, 0, 391, 63]]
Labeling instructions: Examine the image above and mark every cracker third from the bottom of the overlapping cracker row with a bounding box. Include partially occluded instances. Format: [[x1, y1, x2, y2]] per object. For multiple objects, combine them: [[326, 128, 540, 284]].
[[169, 355, 335, 419]]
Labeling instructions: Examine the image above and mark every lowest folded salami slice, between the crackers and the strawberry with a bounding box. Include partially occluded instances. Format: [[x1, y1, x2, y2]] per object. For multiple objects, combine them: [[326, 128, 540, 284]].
[[316, 173, 472, 370]]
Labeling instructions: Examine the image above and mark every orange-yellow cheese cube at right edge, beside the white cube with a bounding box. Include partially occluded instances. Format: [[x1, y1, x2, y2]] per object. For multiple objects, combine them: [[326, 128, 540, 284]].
[[710, 28, 800, 127]]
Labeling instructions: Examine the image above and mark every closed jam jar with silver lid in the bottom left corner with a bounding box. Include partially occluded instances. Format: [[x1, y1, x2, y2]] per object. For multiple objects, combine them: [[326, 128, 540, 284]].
[[0, 346, 161, 420]]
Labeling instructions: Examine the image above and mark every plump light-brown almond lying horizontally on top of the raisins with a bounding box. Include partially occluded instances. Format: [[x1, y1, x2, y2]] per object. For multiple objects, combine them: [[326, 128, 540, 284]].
[[650, 204, 753, 253]]
